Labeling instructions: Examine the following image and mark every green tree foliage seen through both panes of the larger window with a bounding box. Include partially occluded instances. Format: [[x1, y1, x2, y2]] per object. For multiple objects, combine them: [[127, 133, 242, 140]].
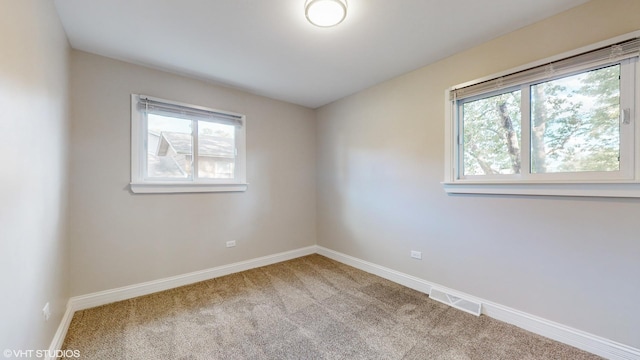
[[461, 65, 620, 175]]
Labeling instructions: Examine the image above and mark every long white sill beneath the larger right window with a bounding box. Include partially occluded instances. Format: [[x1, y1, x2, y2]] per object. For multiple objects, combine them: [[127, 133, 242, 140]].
[[442, 182, 640, 198]]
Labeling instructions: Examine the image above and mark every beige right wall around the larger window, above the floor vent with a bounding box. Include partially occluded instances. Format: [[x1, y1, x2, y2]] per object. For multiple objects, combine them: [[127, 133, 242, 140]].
[[317, 0, 640, 348]]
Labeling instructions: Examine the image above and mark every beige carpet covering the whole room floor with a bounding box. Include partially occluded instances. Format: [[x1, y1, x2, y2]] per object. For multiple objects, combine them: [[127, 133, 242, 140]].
[[64, 255, 598, 360]]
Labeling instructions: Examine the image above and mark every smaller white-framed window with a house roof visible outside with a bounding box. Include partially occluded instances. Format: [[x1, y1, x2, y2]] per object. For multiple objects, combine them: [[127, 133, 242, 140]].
[[131, 94, 247, 193]]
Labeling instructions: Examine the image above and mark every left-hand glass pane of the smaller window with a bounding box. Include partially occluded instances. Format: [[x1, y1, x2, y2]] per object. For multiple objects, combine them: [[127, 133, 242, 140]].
[[147, 114, 193, 179]]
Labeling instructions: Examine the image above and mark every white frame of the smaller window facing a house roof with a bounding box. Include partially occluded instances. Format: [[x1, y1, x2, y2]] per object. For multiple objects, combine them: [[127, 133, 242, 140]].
[[130, 94, 248, 194]]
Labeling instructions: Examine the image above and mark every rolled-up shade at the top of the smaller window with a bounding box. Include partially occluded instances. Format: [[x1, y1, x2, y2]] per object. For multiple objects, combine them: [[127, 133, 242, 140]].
[[138, 96, 243, 127]]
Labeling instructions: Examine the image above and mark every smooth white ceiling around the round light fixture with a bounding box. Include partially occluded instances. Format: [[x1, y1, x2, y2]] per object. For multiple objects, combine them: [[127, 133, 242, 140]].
[[54, 0, 587, 108]]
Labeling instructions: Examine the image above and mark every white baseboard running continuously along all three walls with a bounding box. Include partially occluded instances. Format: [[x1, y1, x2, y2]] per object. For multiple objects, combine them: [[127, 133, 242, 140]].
[[49, 245, 640, 360]]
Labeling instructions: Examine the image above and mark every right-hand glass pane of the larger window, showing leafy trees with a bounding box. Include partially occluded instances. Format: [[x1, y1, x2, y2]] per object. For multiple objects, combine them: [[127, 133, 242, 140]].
[[531, 65, 620, 173]]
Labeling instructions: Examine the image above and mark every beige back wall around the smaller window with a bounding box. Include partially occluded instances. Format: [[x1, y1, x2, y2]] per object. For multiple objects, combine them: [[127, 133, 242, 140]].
[[70, 51, 316, 295]]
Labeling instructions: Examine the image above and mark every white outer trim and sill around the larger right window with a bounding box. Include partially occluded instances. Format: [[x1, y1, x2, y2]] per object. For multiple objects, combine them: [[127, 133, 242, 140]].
[[442, 31, 640, 197]]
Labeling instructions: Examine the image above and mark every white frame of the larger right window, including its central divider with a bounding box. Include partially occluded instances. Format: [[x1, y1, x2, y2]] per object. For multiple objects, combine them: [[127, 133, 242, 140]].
[[442, 31, 640, 197]]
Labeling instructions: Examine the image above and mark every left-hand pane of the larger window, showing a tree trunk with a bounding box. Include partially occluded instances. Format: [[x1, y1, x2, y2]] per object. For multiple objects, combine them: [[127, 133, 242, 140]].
[[461, 90, 521, 175]]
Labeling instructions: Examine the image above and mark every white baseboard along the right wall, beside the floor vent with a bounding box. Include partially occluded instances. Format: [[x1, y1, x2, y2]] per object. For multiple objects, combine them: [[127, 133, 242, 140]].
[[317, 246, 640, 360]]
